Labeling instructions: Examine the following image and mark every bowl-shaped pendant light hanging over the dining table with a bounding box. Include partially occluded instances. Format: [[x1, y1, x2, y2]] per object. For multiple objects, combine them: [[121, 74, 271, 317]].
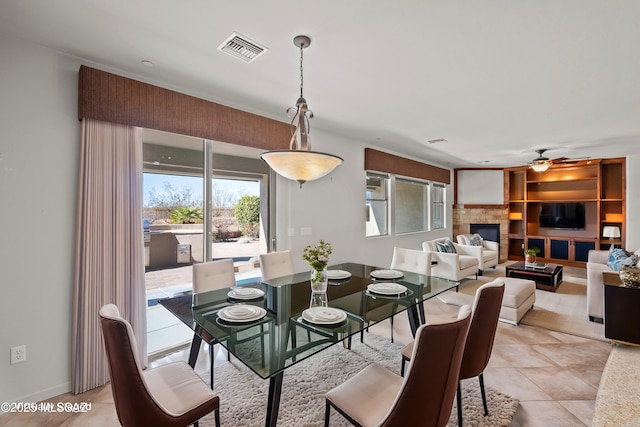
[[260, 36, 343, 187]]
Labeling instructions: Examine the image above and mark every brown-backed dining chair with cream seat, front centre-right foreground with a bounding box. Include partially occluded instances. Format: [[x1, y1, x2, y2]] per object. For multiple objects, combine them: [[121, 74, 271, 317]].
[[324, 305, 470, 427]]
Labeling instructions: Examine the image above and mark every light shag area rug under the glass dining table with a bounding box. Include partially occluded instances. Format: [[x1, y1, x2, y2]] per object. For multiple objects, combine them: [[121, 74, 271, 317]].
[[200, 334, 519, 427]]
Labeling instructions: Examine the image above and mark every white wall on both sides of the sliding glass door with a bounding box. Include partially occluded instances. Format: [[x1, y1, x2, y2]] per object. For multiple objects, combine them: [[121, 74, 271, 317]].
[[0, 37, 453, 402]]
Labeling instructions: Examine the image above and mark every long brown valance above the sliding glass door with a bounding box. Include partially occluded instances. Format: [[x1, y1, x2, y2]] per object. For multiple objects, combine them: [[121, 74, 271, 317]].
[[78, 65, 291, 150]]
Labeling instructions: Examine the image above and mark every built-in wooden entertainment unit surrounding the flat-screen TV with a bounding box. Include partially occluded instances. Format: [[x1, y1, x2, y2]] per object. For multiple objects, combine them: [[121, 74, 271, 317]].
[[505, 158, 626, 266]]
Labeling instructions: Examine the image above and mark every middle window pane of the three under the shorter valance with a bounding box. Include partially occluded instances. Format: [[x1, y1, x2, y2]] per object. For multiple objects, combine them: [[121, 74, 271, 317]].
[[395, 178, 429, 234]]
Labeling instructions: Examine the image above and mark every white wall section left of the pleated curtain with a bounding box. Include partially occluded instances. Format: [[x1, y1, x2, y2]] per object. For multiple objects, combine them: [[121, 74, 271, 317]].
[[0, 38, 80, 402]]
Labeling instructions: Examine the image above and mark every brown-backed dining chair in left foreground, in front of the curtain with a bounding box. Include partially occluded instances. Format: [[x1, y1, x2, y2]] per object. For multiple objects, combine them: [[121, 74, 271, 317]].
[[99, 304, 220, 427]]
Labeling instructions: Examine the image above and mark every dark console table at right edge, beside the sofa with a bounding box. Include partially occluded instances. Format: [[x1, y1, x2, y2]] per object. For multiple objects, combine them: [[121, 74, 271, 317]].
[[602, 271, 640, 345]]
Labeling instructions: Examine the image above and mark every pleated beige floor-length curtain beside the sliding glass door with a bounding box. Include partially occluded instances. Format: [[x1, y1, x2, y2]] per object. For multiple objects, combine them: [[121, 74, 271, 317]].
[[72, 119, 147, 393]]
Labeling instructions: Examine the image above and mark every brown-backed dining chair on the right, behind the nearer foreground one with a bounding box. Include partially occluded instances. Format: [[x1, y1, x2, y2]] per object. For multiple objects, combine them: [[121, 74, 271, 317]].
[[401, 279, 504, 426]]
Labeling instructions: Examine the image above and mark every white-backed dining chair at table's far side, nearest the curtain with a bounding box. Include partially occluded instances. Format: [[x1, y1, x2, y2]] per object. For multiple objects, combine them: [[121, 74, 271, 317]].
[[192, 259, 236, 388]]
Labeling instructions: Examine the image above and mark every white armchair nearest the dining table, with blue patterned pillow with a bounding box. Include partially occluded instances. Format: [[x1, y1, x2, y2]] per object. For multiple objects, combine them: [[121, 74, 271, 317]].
[[422, 237, 478, 288]]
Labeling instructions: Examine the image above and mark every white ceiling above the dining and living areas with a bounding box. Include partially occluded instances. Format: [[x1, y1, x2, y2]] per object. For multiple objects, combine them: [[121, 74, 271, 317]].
[[0, 0, 640, 167]]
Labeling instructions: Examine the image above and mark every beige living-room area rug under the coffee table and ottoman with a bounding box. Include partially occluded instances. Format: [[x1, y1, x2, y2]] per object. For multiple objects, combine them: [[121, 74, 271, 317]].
[[442, 265, 609, 342]]
